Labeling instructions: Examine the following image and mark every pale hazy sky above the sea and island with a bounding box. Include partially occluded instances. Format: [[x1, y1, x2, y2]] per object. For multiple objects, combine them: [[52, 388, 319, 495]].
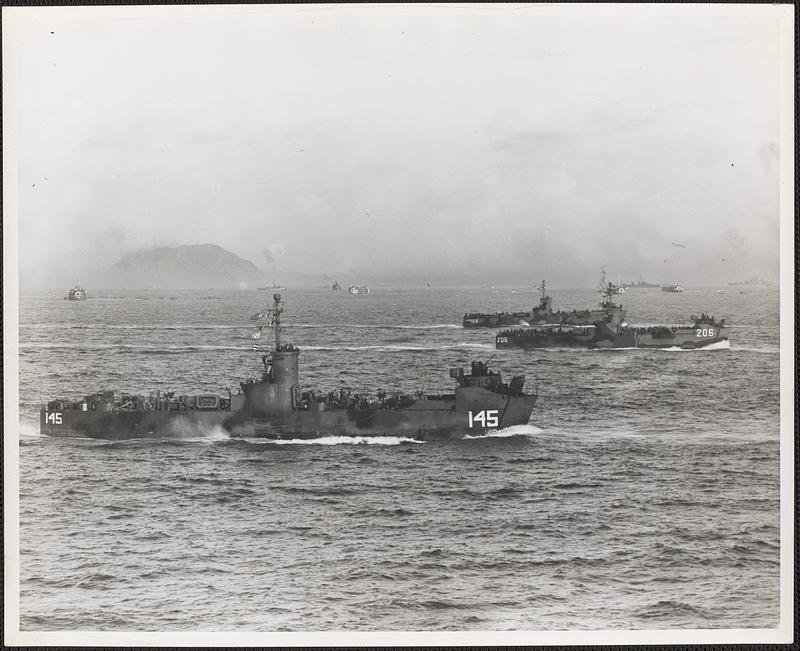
[[3, 6, 791, 285]]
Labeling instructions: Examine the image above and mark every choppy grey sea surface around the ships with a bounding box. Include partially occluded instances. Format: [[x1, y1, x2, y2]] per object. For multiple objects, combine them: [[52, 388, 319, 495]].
[[19, 287, 780, 631]]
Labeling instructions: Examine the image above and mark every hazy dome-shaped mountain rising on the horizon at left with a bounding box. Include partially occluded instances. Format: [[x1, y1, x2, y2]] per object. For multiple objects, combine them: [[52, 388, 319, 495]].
[[103, 244, 267, 289]]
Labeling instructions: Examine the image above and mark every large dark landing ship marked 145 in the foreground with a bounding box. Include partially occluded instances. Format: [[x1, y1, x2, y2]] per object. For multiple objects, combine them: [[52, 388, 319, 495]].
[[39, 294, 537, 440]]
